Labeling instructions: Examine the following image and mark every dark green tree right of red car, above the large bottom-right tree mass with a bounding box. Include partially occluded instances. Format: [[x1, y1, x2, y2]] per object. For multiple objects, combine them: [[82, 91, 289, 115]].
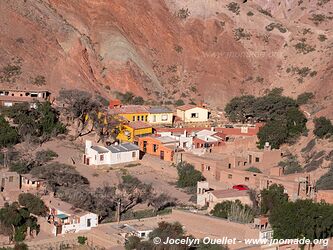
[[260, 184, 288, 214]]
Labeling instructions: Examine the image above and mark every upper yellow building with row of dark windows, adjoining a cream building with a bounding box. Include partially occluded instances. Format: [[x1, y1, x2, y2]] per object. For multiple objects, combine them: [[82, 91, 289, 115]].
[[109, 105, 149, 122]]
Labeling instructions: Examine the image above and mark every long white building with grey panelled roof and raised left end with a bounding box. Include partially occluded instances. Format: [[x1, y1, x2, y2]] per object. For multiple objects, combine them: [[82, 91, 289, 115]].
[[83, 140, 139, 165]]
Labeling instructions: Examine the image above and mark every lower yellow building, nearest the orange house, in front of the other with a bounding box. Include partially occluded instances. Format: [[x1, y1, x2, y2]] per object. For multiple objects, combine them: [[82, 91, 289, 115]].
[[117, 121, 153, 142]]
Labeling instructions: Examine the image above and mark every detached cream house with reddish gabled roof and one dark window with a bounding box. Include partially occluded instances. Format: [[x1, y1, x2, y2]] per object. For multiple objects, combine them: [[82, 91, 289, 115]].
[[177, 105, 209, 123]]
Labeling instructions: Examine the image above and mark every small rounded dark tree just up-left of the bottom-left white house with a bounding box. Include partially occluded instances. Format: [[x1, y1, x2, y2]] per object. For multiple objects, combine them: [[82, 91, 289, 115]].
[[18, 193, 47, 216]]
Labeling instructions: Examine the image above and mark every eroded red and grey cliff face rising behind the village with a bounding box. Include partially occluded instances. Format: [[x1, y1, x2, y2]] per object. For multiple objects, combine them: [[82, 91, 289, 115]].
[[0, 0, 333, 114]]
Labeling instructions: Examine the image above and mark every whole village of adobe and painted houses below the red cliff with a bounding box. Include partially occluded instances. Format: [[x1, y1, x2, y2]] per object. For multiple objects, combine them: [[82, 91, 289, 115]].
[[0, 90, 333, 249]]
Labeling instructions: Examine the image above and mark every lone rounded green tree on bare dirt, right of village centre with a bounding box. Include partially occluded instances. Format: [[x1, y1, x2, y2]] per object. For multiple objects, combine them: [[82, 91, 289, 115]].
[[177, 162, 205, 188]]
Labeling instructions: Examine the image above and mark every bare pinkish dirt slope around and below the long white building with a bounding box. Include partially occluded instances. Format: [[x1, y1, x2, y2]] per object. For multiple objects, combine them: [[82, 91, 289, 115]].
[[28, 139, 191, 204]]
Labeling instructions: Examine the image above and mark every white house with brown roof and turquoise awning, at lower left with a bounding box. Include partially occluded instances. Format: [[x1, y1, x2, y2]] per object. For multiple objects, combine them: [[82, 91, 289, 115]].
[[42, 195, 98, 236]]
